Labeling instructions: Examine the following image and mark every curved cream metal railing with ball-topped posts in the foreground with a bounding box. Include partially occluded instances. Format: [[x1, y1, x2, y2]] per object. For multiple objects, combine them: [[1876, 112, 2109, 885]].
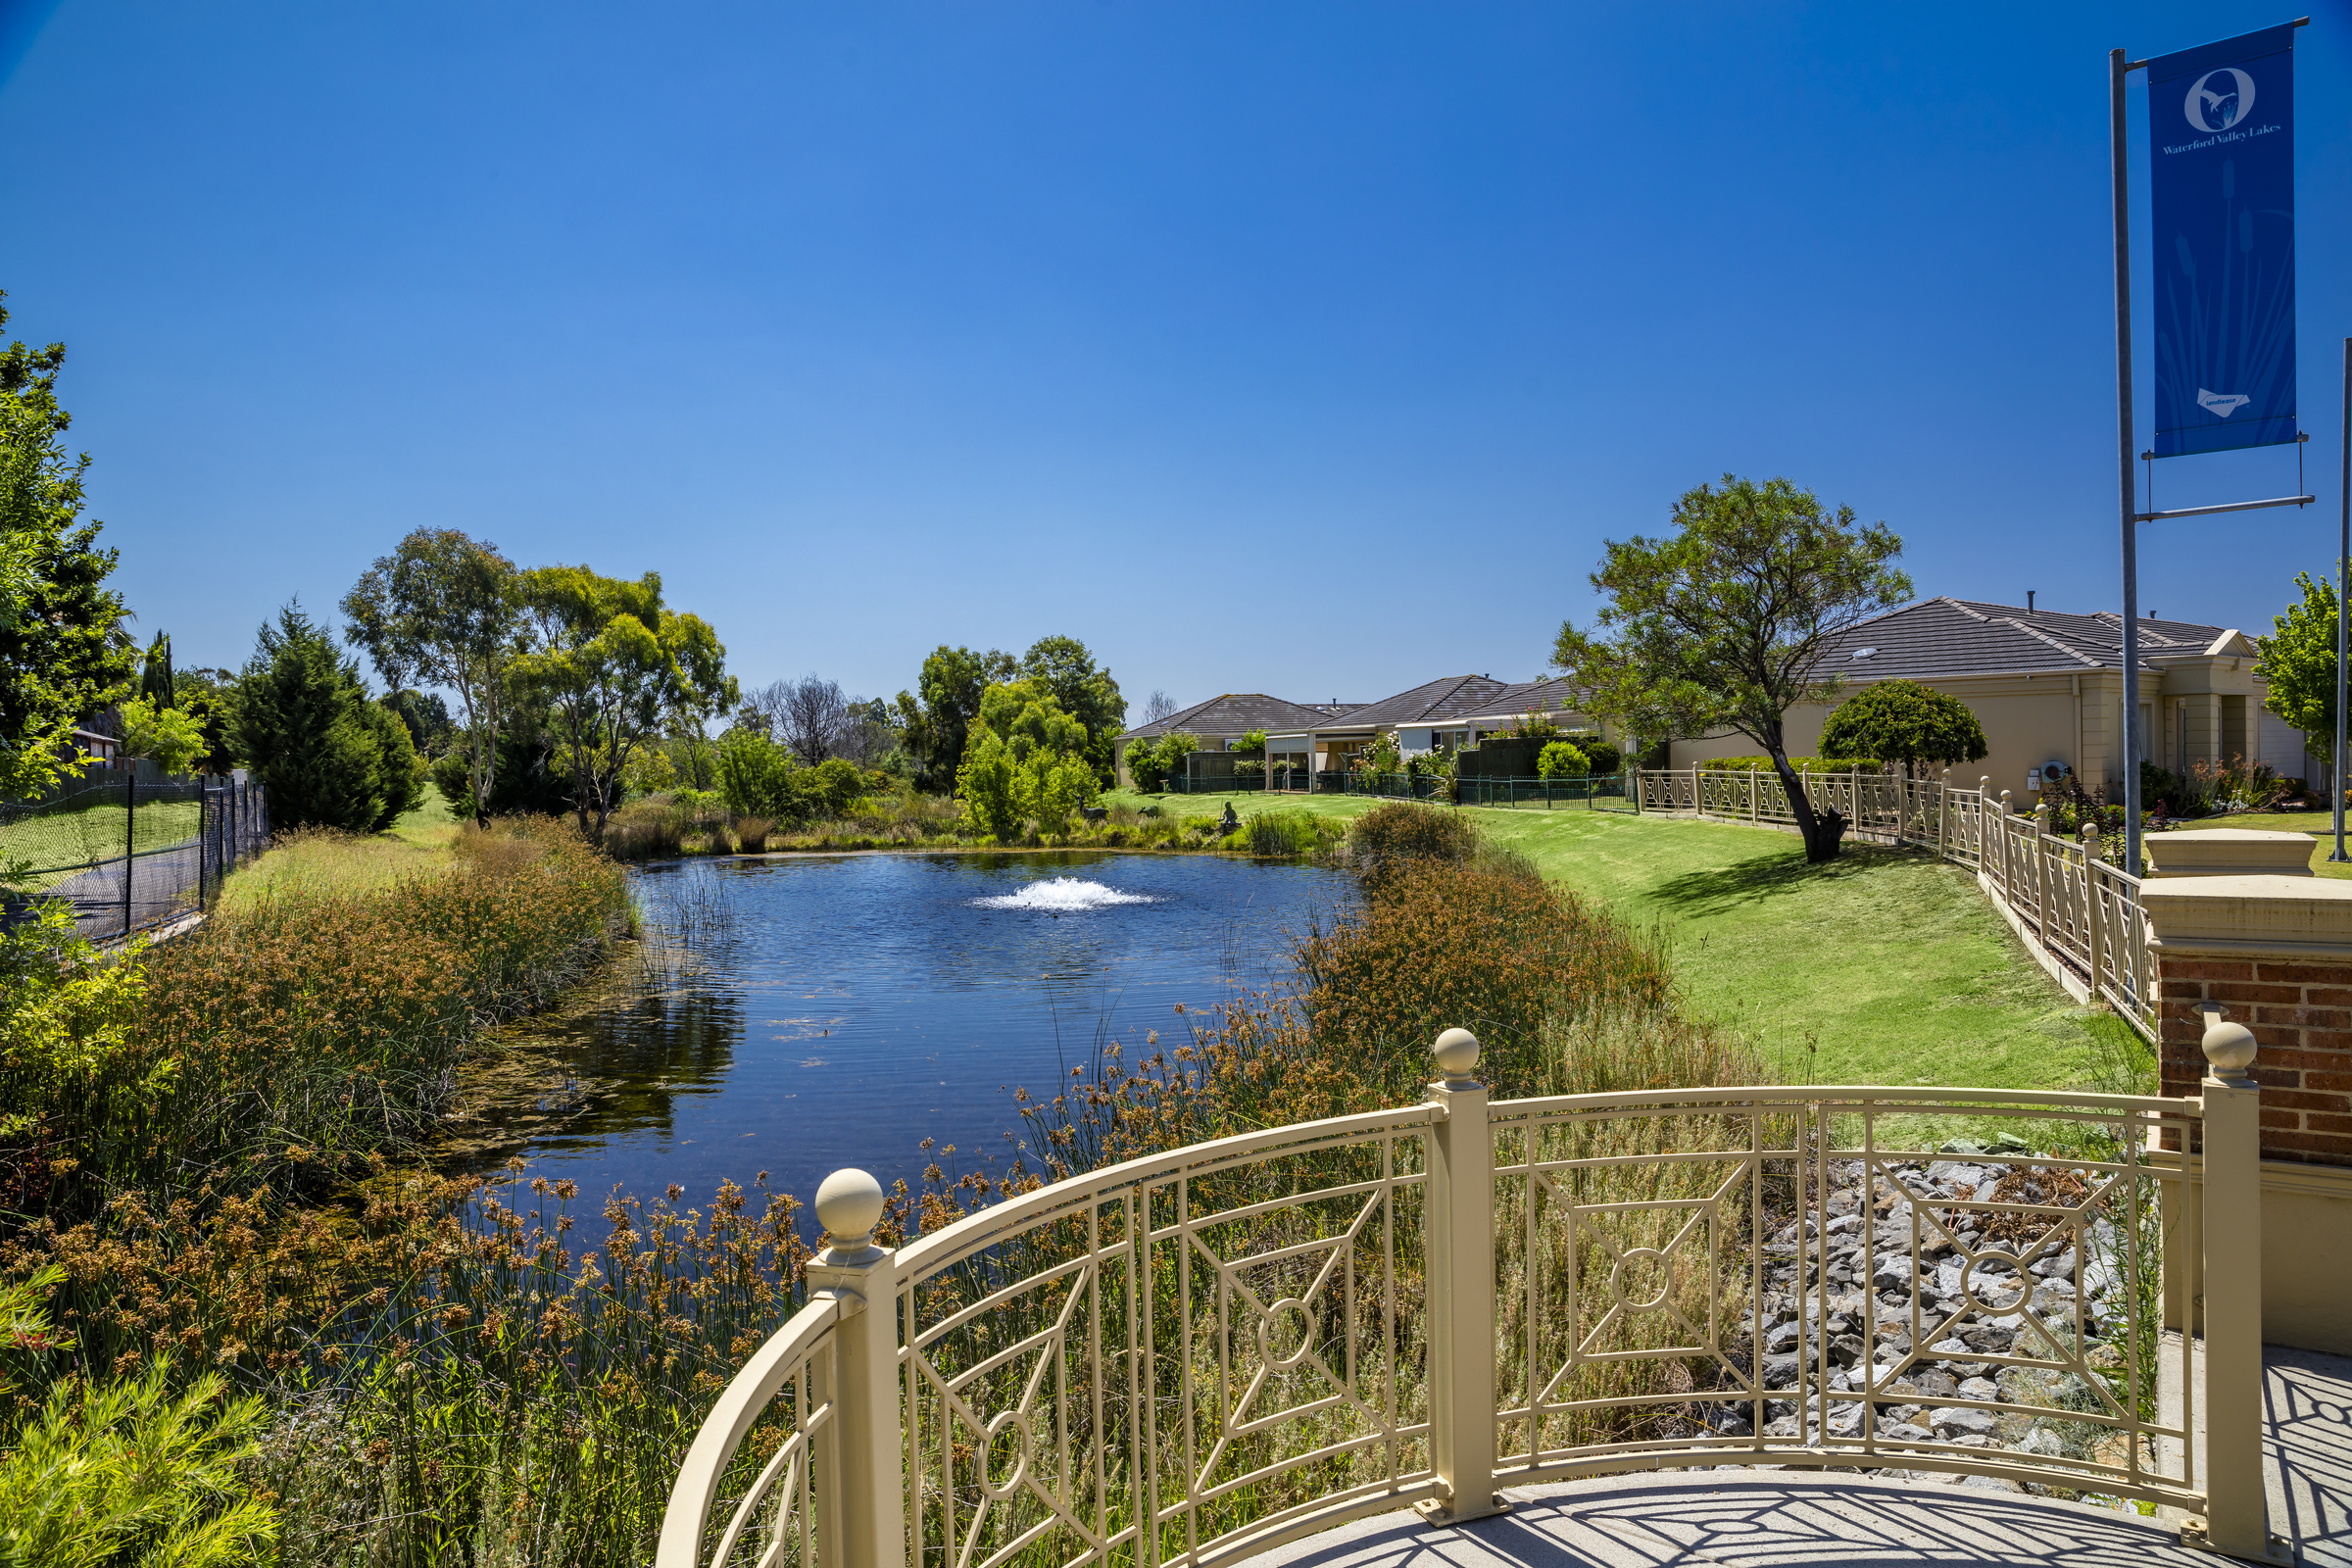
[[657, 1025, 2268, 1568]]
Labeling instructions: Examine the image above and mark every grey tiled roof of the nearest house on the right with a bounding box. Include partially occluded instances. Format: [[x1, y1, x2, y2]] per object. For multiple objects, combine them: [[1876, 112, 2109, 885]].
[[1825, 600, 2230, 679]]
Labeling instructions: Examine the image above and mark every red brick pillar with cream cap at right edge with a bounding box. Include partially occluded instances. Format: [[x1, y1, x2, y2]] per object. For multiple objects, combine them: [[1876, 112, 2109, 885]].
[[2140, 877, 2352, 1354]]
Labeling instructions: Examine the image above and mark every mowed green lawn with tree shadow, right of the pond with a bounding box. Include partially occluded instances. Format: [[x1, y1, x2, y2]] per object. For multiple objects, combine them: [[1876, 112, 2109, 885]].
[[1119, 792, 2124, 1089]]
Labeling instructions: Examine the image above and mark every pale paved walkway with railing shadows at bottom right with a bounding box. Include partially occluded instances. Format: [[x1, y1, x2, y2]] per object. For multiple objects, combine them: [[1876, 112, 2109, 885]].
[[1251, 1349, 2352, 1568]]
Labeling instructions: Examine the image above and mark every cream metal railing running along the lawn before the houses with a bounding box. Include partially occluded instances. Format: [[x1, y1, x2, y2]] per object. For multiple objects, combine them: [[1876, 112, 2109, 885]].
[[1637, 768, 2157, 1039]]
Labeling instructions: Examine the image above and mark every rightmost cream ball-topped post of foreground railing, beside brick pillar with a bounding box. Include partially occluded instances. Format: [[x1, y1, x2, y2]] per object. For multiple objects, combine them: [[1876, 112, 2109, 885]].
[[2182, 1002, 2291, 1561]]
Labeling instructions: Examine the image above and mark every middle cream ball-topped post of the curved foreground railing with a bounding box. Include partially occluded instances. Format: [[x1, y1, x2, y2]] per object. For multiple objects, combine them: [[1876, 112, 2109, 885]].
[[1413, 1030, 1507, 1523]]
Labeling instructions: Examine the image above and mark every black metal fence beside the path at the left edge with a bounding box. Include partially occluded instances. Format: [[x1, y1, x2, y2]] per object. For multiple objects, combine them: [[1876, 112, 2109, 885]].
[[0, 768, 270, 943]]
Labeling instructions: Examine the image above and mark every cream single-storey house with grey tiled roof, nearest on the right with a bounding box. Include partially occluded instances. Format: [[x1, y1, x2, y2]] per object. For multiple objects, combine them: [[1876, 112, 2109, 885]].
[[1672, 597, 2319, 804]]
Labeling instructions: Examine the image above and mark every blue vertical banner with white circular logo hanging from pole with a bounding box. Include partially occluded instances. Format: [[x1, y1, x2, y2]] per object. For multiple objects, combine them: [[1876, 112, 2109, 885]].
[[2147, 24, 2295, 459]]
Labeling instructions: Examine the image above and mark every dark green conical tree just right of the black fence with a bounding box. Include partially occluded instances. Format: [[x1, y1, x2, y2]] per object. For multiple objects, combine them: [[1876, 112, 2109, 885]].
[[230, 604, 390, 832]]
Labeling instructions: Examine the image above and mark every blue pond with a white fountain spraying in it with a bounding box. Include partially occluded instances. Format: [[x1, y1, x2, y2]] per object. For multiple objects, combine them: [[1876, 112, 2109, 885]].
[[447, 854, 1352, 1203]]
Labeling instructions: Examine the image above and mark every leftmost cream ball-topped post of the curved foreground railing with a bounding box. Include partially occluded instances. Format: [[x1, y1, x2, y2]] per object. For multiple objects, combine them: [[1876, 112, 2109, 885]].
[[809, 1171, 906, 1568]]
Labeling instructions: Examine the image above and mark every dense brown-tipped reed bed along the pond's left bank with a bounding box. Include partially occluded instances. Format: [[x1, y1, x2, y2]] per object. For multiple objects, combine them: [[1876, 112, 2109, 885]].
[[0, 818, 630, 1213]]
